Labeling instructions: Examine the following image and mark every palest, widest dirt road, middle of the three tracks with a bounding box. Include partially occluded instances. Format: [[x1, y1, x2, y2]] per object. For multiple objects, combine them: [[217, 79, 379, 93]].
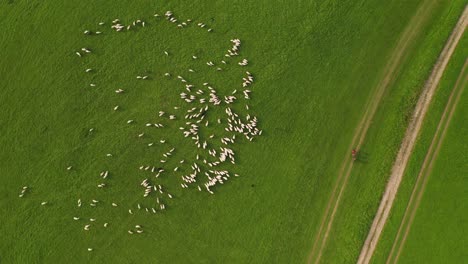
[[358, 7, 468, 264]]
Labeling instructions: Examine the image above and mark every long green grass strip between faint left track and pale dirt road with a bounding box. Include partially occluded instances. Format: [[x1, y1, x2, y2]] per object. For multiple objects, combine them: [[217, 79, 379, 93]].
[[323, 1, 464, 263]]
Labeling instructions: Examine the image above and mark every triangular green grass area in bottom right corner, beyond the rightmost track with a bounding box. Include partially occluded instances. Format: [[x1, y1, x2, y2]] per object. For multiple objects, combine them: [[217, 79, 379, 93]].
[[399, 91, 468, 263]]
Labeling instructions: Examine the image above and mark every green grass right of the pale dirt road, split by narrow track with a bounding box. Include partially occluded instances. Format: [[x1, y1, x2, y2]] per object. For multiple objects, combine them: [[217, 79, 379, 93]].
[[372, 32, 468, 263]]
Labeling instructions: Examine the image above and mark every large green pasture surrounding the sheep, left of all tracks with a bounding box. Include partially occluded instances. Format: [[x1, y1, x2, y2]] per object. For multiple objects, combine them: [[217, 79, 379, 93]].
[[0, 1, 462, 263]]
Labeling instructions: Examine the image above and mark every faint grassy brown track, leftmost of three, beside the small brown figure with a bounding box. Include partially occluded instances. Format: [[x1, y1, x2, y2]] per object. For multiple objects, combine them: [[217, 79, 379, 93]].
[[307, 0, 435, 263]]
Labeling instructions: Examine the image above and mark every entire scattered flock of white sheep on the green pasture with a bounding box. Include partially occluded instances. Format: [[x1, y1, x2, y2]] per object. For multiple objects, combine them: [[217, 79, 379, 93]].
[[15, 11, 262, 254]]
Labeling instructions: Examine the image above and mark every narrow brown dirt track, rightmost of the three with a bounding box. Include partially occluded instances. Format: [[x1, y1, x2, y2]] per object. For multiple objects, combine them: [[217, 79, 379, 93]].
[[387, 60, 468, 263]]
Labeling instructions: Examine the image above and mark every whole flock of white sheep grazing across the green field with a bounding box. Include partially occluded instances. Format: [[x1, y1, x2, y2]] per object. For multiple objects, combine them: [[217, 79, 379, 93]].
[[19, 11, 262, 254]]
